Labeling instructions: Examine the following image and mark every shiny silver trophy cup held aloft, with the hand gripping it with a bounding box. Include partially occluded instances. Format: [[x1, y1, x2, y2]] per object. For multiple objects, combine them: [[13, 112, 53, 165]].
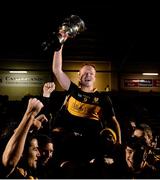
[[42, 15, 86, 51]]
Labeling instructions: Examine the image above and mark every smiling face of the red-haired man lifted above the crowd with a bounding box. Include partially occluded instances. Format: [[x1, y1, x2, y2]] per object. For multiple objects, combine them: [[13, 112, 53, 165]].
[[79, 65, 96, 87]]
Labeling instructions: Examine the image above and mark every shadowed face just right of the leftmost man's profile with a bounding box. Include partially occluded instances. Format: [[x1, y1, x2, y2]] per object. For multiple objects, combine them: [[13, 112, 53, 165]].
[[40, 143, 54, 165]]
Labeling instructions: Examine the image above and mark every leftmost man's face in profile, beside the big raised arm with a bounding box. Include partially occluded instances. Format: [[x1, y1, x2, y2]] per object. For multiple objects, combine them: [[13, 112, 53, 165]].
[[28, 139, 40, 169]]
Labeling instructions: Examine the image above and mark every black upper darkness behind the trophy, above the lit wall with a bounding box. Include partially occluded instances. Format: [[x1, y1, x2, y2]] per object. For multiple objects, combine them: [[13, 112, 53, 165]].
[[0, 1, 160, 67]]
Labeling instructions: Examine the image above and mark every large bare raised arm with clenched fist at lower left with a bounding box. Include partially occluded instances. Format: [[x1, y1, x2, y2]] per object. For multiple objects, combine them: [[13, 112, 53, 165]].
[[2, 98, 46, 175]]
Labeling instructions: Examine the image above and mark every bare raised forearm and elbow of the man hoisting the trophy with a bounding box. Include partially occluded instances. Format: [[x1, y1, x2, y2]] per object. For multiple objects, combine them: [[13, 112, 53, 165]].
[[52, 39, 71, 90]]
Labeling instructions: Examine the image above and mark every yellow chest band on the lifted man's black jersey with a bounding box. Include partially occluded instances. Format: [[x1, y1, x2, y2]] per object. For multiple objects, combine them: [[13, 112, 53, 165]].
[[66, 97, 101, 120]]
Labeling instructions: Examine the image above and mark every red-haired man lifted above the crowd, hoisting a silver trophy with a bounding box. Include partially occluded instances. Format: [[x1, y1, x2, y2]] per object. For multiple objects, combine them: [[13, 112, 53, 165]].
[[46, 15, 121, 162]]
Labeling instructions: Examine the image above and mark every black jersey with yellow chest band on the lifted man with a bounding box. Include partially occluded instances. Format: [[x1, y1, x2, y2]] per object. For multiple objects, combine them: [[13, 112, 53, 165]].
[[56, 82, 114, 134]]
